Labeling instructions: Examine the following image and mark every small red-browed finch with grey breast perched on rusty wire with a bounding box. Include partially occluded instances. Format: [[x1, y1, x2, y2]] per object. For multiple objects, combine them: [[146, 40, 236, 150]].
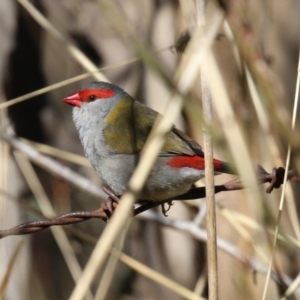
[[63, 81, 233, 214]]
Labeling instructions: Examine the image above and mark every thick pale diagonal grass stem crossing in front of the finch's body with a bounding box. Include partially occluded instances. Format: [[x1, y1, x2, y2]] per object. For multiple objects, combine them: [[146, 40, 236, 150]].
[[70, 14, 222, 300]]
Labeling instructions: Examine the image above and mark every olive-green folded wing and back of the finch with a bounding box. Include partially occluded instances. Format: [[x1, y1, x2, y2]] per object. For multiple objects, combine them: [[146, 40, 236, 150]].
[[103, 97, 202, 156]]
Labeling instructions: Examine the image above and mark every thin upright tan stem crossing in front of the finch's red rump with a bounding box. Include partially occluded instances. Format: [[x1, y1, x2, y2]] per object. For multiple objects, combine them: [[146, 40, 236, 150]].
[[196, 0, 218, 300]]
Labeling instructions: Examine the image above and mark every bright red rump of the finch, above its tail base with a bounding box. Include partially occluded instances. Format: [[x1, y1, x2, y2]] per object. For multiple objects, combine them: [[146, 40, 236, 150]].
[[166, 155, 223, 170]]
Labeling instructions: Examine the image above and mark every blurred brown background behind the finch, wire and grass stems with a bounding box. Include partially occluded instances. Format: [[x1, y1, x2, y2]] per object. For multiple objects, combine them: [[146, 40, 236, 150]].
[[0, 0, 300, 300]]
